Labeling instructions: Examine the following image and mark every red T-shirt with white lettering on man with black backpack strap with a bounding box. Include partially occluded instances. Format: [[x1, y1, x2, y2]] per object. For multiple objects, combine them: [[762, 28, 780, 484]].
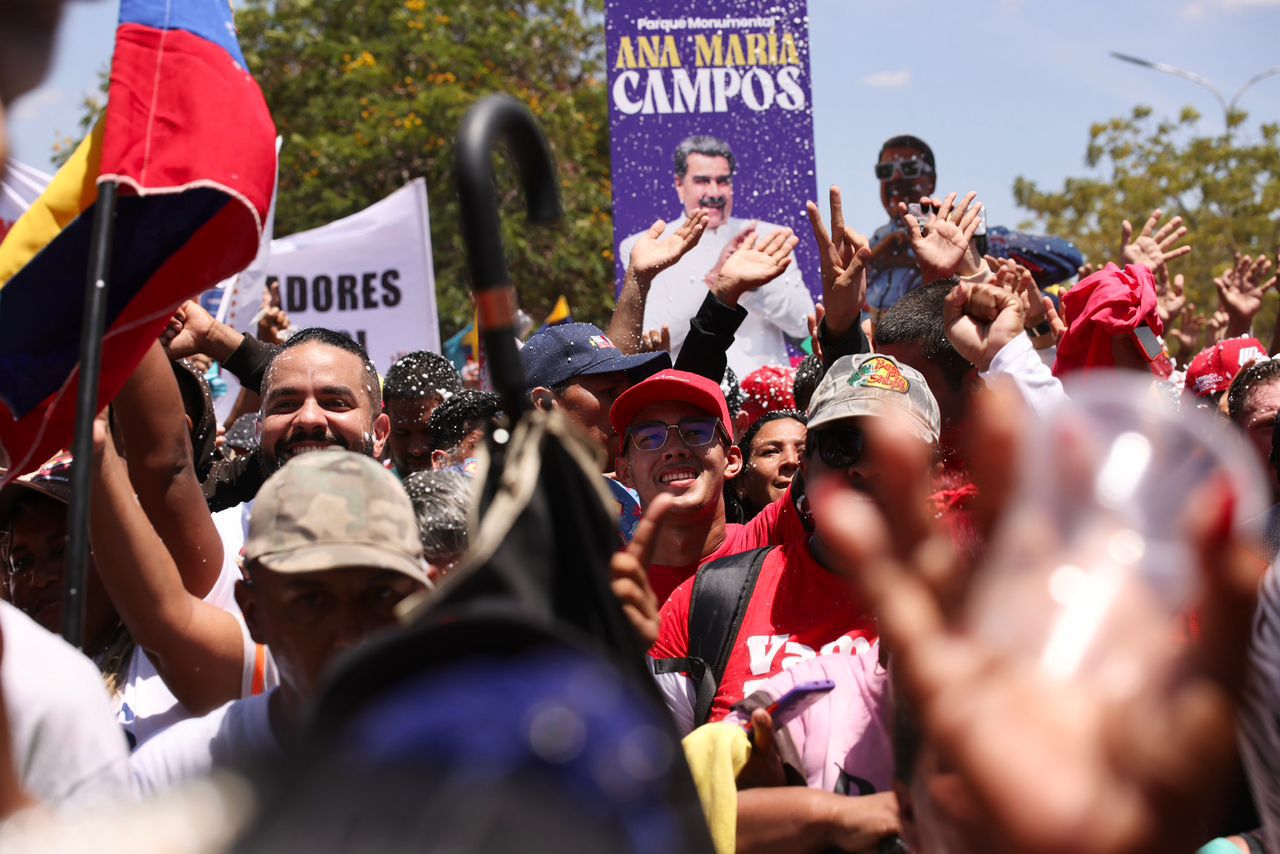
[[649, 538, 877, 721]]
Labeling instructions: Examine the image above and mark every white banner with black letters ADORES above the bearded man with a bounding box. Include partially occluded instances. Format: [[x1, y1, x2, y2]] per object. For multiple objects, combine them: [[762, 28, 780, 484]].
[[227, 178, 440, 374]]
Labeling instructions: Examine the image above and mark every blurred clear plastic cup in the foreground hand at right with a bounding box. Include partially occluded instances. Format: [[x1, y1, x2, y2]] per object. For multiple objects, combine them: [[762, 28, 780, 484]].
[[964, 371, 1268, 698]]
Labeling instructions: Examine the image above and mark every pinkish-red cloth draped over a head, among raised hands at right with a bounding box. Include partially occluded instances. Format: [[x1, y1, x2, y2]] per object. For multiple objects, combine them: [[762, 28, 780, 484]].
[[1053, 264, 1165, 376]]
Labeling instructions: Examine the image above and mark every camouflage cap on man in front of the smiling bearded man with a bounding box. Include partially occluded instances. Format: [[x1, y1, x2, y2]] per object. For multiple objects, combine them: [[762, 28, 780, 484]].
[[244, 449, 428, 584]]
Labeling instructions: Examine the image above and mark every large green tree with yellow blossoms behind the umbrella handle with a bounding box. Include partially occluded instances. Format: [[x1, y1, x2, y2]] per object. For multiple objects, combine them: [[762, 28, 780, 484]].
[[229, 0, 613, 335]]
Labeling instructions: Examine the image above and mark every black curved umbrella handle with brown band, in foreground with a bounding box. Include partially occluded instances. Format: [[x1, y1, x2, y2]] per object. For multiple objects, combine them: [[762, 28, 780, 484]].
[[453, 95, 561, 420]]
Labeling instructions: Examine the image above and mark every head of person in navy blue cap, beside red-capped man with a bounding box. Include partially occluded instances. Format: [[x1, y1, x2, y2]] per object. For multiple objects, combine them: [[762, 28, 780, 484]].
[[520, 323, 671, 468]]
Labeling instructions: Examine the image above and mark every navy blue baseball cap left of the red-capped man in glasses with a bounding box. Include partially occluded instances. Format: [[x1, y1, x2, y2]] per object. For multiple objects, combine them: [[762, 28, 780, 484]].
[[520, 323, 671, 392]]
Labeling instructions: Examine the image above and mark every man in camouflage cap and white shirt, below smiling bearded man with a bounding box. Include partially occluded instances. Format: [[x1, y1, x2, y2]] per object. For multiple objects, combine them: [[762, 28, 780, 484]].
[[131, 449, 429, 794]]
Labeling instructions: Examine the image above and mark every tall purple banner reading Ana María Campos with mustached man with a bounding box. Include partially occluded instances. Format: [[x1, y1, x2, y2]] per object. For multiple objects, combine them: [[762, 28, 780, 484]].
[[605, 0, 822, 378]]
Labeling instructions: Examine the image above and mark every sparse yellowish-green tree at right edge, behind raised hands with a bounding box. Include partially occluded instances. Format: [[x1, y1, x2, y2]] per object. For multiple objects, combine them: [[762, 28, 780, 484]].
[[1014, 106, 1280, 343]]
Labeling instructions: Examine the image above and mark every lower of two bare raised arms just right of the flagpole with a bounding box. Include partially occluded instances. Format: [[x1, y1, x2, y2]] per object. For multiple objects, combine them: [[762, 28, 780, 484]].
[[90, 416, 244, 714]]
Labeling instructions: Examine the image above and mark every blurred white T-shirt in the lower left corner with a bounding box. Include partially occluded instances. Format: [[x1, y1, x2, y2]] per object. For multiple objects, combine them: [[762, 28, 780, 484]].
[[0, 602, 129, 807]]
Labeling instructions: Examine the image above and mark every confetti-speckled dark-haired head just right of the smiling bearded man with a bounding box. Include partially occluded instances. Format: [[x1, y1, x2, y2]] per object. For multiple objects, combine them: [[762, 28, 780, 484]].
[[383, 350, 462, 478]]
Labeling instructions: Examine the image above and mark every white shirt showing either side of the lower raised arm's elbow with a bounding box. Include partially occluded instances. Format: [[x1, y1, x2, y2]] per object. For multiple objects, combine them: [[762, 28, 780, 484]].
[[115, 524, 279, 749]]
